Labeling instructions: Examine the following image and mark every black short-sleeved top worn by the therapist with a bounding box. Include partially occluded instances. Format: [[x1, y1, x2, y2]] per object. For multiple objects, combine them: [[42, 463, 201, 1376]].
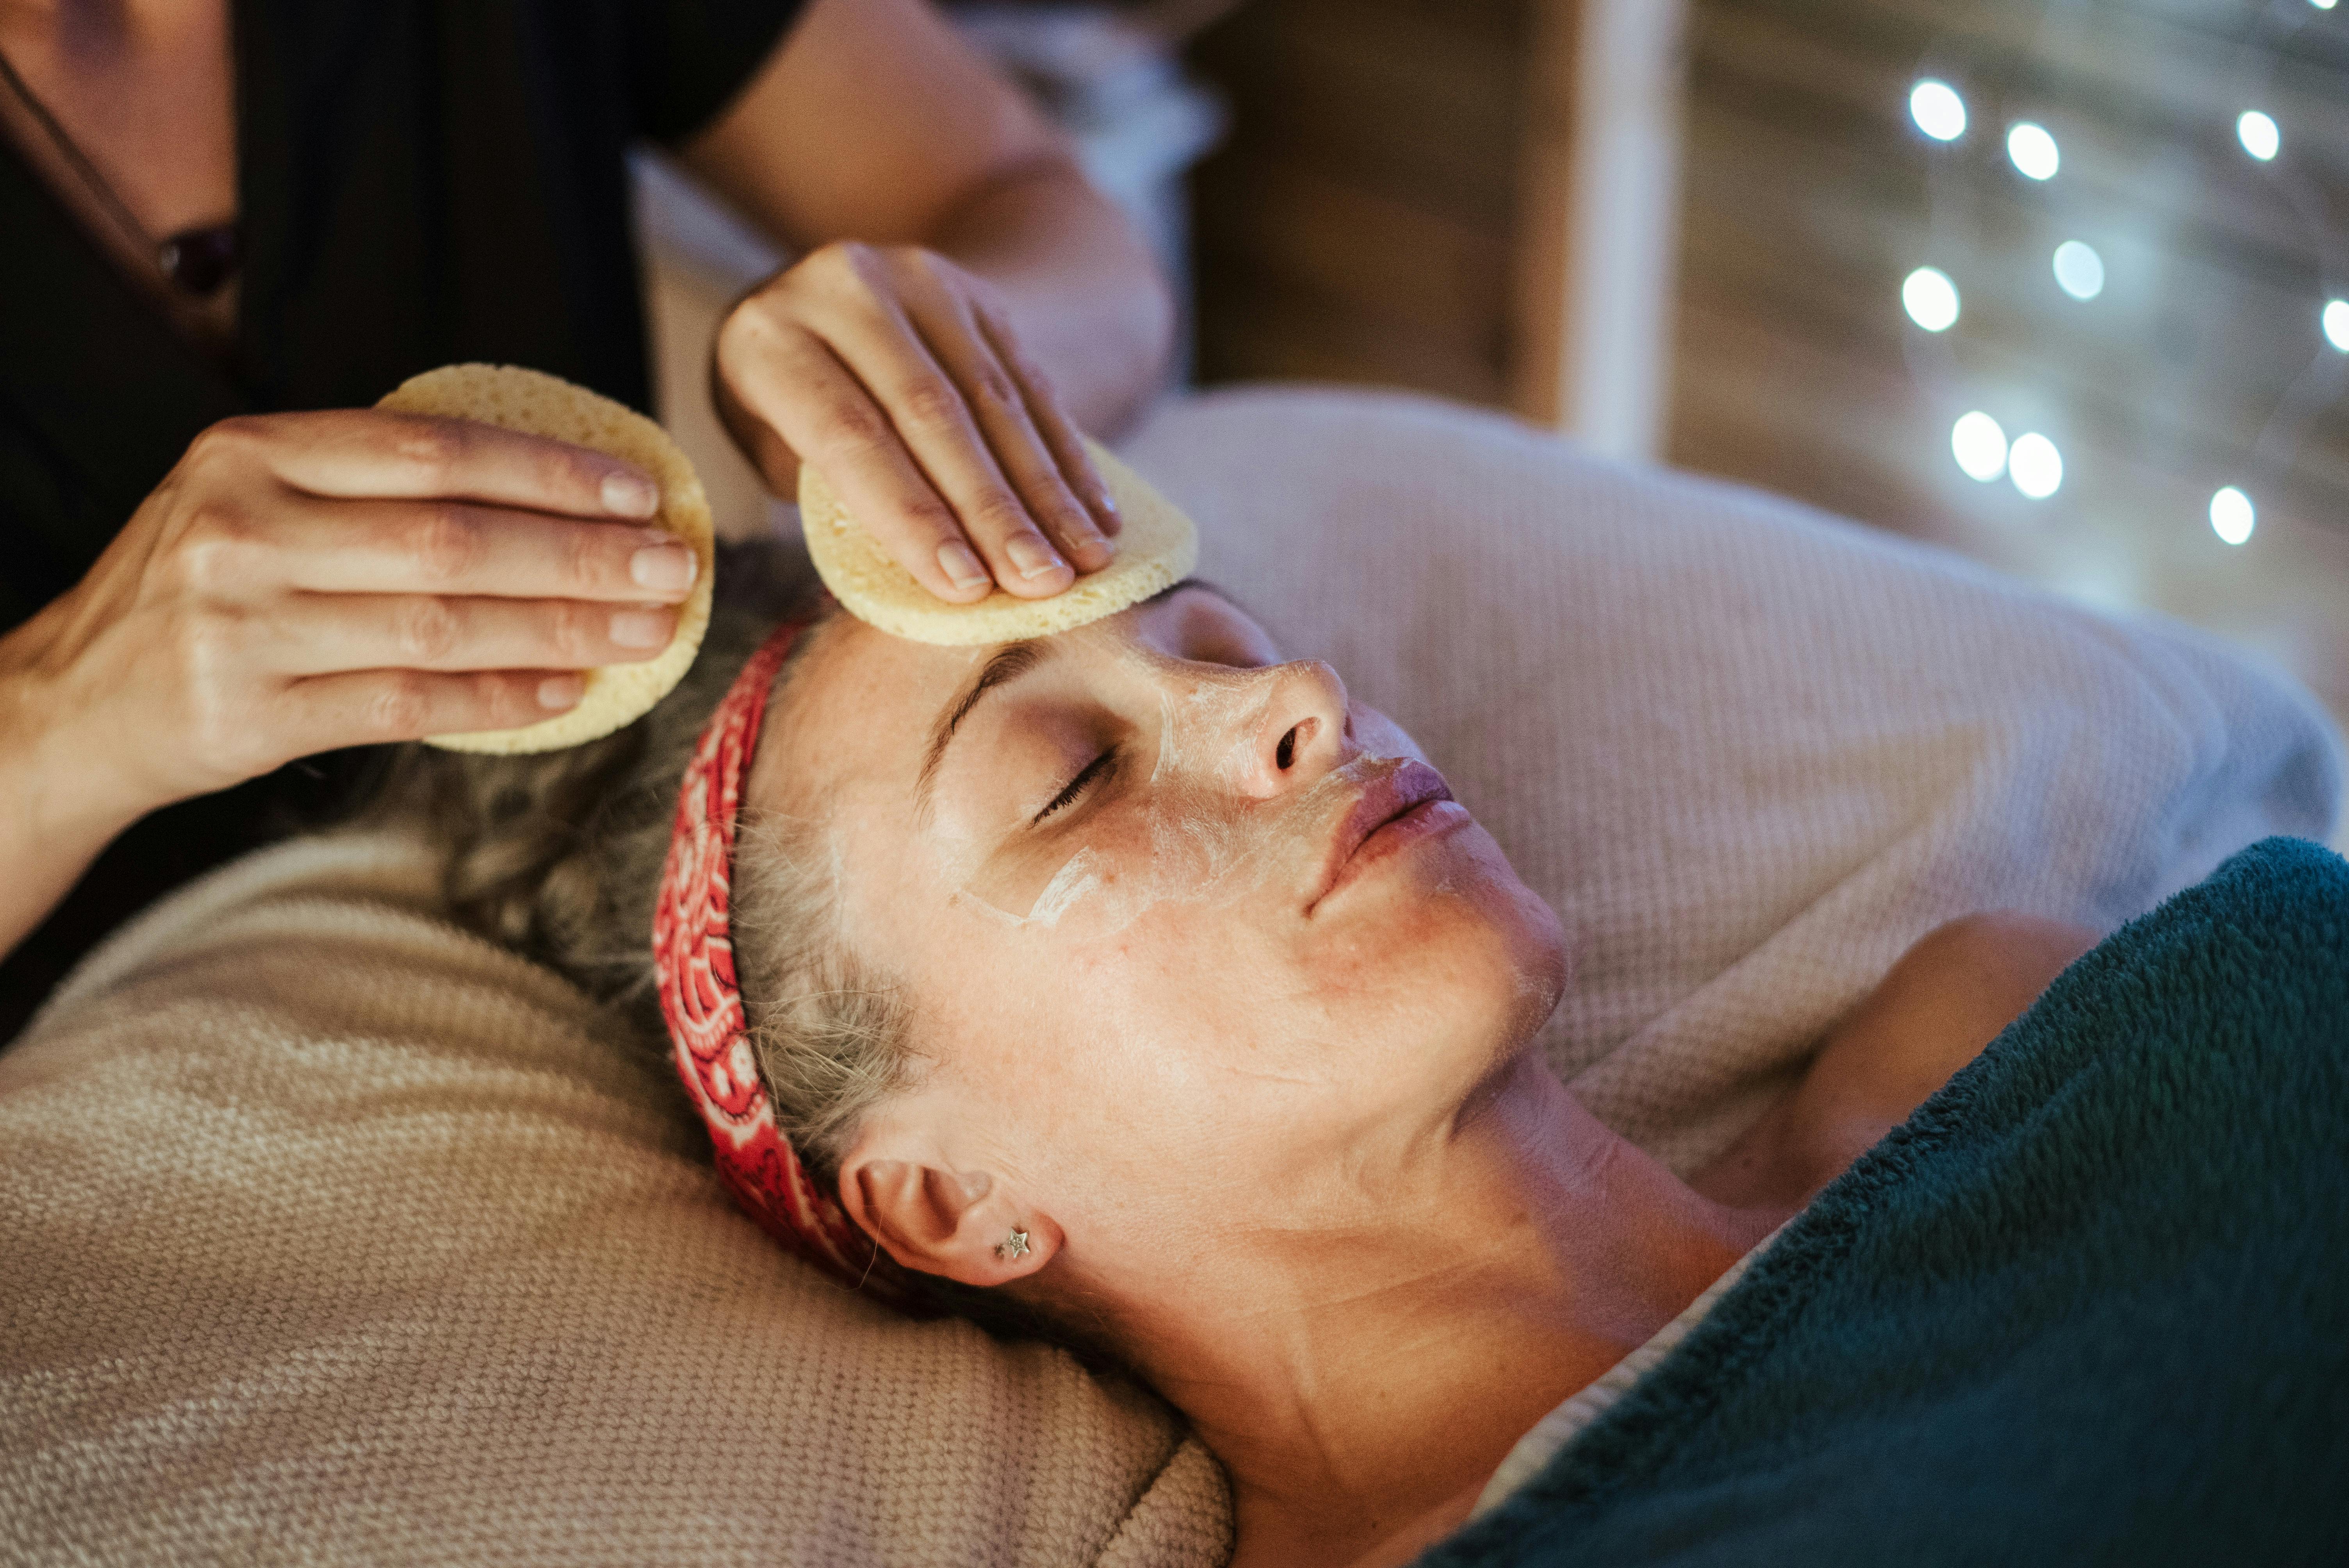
[[0, 0, 798, 1042]]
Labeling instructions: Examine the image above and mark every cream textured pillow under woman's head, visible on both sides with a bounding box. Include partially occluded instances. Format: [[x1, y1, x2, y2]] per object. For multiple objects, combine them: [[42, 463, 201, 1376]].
[[0, 392, 2340, 1568]]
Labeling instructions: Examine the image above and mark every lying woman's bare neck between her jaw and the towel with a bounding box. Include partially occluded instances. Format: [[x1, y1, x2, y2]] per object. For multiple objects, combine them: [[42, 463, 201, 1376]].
[[1121, 1051, 1766, 1568]]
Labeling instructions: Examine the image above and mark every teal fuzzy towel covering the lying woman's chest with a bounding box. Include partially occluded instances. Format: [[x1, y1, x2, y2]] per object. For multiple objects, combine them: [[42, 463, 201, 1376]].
[[1419, 838, 2349, 1568]]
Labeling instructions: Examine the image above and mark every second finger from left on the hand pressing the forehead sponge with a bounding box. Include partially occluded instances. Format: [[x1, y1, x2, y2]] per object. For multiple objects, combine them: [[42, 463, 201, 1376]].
[[811, 272, 1076, 599]]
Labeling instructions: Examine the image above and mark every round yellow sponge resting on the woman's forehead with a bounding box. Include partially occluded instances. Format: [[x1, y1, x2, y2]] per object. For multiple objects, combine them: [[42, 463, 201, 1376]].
[[798, 441, 1198, 648]]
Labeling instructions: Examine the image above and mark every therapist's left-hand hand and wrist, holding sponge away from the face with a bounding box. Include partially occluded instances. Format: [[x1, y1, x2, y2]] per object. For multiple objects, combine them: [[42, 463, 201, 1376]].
[[0, 411, 695, 836]]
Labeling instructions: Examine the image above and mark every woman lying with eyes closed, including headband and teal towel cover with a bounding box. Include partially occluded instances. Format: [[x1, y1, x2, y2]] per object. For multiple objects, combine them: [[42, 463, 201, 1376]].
[[385, 582, 2349, 1568]]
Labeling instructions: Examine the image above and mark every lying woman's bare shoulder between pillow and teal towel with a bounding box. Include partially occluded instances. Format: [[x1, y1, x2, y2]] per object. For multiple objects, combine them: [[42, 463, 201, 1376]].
[[1694, 911, 2098, 1209]]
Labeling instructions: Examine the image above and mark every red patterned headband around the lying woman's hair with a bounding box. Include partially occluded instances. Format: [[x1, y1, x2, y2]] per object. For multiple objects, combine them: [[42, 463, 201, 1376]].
[[653, 622, 918, 1308]]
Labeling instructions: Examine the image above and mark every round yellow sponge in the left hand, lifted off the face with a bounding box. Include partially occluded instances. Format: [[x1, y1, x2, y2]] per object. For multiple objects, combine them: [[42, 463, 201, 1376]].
[[376, 364, 716, 756]]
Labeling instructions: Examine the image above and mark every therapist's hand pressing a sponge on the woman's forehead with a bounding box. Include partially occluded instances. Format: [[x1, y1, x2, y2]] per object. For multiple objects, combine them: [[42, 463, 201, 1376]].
[[712, 242, 1118, 603]]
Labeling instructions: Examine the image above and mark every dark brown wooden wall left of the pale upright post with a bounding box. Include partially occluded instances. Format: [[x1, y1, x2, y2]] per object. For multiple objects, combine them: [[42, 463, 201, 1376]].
[[1189, 0, 1527, 404]]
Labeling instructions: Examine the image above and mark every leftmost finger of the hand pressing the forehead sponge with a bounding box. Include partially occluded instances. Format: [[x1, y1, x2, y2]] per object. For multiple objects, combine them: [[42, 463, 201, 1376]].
[[721, 315, 994, 603]]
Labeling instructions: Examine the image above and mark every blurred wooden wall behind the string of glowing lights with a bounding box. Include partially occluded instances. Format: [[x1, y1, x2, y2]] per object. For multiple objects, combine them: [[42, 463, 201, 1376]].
[[1668, 0, 2349, 709]]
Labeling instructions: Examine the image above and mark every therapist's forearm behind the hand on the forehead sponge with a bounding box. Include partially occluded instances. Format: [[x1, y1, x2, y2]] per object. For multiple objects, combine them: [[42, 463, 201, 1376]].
[[925, 157, 1174, 434]]
